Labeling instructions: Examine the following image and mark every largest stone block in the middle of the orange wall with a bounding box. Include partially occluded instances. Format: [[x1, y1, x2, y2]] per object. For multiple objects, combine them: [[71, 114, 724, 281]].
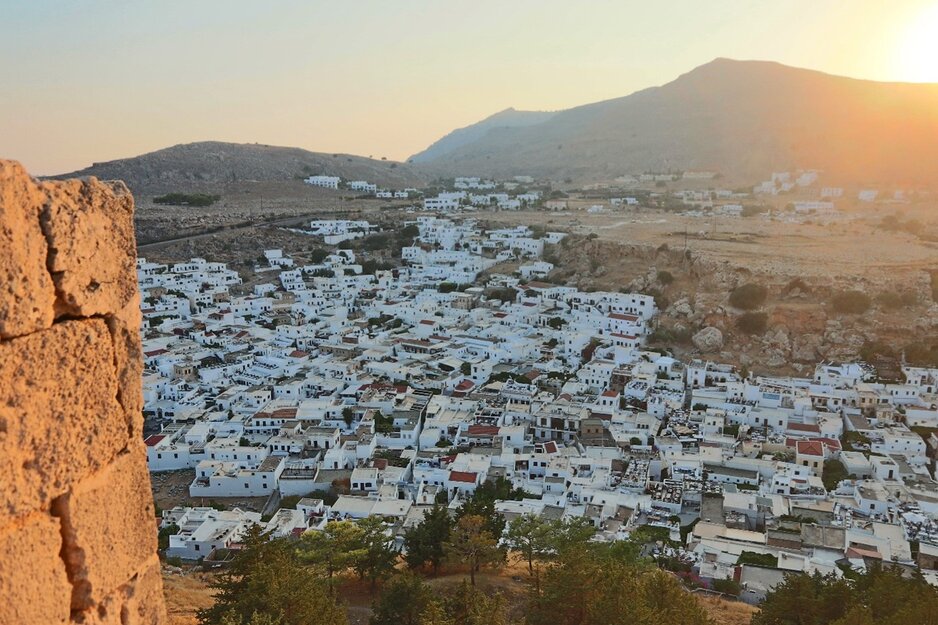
[[0, 319, 130, 526]]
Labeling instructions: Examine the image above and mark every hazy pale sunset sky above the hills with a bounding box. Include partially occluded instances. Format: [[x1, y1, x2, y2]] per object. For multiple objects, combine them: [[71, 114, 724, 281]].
[[0, 0, 938, 174]]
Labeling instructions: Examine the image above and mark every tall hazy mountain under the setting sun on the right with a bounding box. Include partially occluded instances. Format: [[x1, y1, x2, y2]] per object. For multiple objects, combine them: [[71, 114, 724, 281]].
[[414, 59, 938, 184]]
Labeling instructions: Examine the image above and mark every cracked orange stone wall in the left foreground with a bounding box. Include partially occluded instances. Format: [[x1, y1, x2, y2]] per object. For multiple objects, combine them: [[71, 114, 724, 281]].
[[0, 161, 166, 625]]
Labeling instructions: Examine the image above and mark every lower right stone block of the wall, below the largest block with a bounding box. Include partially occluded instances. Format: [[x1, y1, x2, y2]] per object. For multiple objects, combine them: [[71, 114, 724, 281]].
[[53, 442, 156, 610]]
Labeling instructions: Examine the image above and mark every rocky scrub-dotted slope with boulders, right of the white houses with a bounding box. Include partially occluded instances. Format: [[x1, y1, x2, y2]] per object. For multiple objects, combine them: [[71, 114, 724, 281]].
[[546, 236, 938, 374]]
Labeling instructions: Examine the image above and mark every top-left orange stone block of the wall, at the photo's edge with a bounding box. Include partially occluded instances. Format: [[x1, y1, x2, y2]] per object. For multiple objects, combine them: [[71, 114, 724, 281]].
[[0, 161, 55, 339]]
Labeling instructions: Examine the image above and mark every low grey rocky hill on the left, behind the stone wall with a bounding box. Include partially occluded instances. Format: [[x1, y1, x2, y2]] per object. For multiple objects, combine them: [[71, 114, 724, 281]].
[[56, 141, 427, 194]]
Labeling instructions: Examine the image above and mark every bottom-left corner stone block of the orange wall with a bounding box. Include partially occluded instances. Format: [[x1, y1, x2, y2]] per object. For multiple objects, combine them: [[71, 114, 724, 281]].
[[0, 513, 71, 624]]
